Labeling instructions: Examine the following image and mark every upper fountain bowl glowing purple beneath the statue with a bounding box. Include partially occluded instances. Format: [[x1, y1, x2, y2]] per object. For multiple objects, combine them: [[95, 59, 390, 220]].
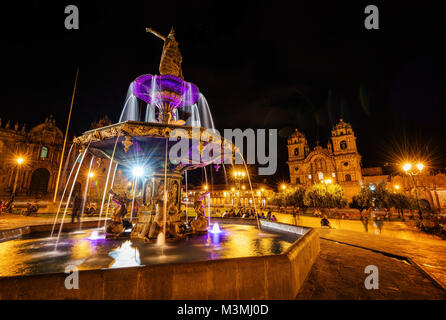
[[132, 74, 200, 108]]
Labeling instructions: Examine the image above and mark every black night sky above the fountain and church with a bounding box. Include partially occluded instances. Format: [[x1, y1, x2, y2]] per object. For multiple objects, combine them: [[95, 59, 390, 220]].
[[0, 1, 446, 184]]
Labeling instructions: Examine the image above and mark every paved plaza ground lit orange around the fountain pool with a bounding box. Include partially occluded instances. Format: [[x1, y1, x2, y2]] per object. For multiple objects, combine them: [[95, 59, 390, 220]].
[[0, 213, 446, 300]]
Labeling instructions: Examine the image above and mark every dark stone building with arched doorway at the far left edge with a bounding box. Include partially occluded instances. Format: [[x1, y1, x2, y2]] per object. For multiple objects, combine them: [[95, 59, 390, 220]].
[[0, 117, 63, 197]]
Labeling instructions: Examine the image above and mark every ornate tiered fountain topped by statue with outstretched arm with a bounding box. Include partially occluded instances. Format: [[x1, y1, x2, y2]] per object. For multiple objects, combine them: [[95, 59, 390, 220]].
[[74, 28, 228, 239]]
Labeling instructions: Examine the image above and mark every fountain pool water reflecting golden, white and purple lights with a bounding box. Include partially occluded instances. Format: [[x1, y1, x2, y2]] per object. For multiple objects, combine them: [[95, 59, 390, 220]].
[[0, 225, 297, 276]]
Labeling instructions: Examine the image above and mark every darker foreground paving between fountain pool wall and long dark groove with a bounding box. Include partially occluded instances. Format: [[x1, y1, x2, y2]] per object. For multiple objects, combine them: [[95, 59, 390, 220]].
[[296, 240, 446, 300]]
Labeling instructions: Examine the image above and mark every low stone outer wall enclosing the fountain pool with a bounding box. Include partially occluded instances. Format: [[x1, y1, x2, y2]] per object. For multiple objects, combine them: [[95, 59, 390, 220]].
[[0, 221, 320, 300]]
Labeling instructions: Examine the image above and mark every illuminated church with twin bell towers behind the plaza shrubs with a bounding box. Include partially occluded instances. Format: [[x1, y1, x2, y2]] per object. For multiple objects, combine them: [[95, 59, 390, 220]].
[[287, 119, 362, 200]]
